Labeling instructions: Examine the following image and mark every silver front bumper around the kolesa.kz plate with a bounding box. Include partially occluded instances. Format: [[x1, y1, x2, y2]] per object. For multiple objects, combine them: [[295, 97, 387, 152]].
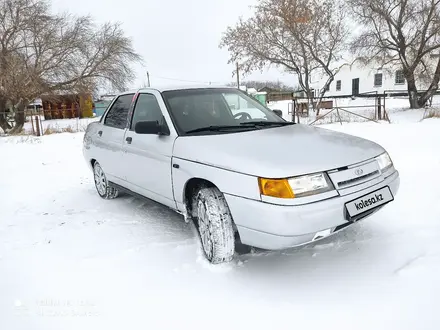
[[225, 171, 400, 250]]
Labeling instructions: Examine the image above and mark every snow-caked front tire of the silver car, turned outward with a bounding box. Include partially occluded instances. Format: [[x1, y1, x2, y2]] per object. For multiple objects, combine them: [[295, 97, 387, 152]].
[[193, 188, 235, 264]]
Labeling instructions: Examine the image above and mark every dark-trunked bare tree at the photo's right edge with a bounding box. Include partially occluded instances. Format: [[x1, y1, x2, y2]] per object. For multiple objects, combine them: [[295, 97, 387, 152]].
[[347, 0, 440, 108]]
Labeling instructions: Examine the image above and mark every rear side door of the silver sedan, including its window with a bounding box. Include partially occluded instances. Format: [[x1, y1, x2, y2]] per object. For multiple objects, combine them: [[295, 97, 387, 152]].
[[96, 94, 134, 184]]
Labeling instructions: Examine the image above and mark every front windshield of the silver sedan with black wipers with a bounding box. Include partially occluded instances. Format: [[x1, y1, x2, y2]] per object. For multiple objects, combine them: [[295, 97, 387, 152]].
[[162, 88, 290, 135]]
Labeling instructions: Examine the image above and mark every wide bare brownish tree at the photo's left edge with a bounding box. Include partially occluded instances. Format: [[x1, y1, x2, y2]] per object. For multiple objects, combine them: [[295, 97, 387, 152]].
[[0, 0, 141, 131]]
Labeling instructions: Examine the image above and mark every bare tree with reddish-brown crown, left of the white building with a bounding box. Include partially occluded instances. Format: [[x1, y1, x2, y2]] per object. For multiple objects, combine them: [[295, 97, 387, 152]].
[[220, 0, 349, 113]]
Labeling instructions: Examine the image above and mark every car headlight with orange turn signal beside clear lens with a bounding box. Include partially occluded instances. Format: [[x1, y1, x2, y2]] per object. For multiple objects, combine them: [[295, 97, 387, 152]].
[[258, 173, 334, 198]]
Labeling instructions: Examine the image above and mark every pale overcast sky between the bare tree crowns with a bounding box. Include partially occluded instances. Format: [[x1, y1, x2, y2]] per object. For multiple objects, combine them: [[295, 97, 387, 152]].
[[52, 0, 296, 88]]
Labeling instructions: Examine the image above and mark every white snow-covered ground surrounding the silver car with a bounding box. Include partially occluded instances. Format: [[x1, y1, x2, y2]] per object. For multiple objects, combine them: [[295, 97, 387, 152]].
[[0, 112, 440, 330]]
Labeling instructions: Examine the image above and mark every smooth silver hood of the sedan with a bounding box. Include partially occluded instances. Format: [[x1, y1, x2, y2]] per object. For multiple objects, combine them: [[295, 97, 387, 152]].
[[173, 124, 385, 178]]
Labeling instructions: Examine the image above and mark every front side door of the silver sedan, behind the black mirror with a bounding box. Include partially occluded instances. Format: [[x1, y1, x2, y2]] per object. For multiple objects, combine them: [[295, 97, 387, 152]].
[[123, 91, 177, 208]]
